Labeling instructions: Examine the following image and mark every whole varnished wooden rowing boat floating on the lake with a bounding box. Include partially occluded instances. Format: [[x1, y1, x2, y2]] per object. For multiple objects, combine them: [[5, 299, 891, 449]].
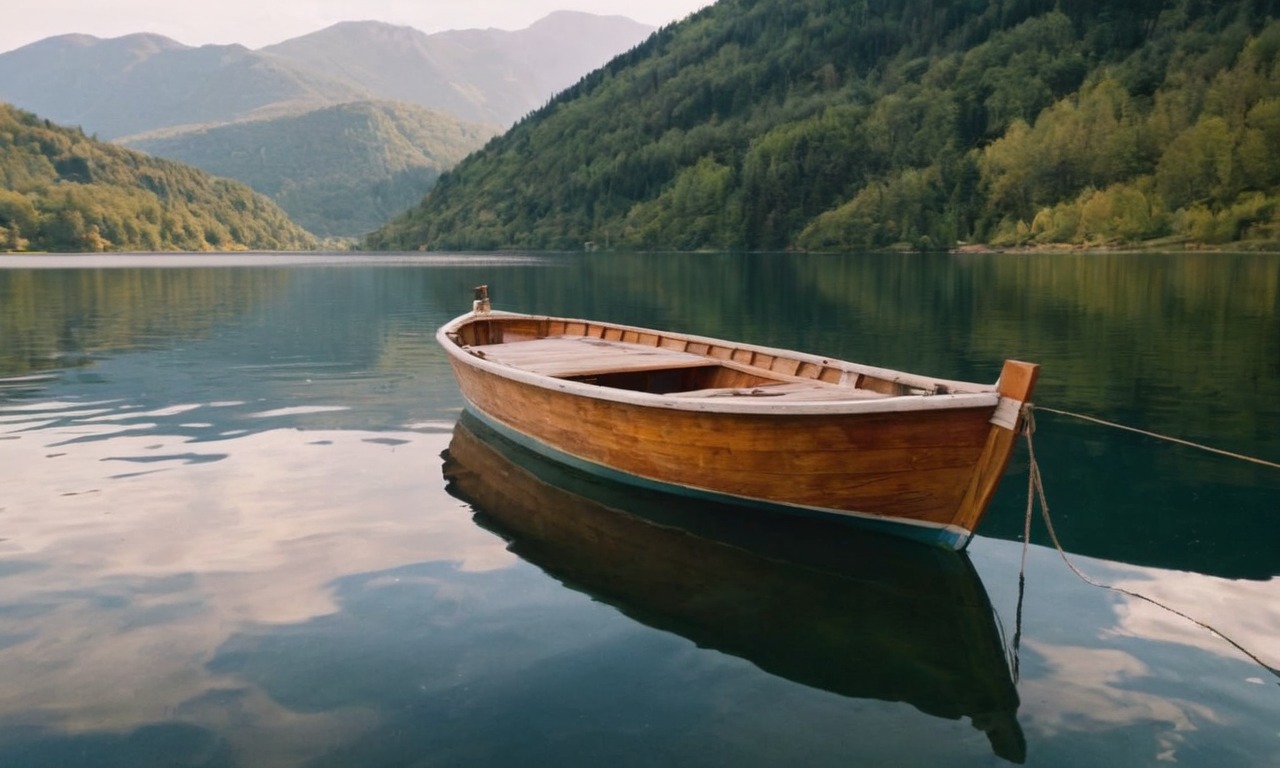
[[436, 287, 1038, 549]]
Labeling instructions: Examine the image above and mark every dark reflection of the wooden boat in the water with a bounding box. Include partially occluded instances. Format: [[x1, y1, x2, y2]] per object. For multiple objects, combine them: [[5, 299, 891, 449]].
[[444, 412, 1027, 763]]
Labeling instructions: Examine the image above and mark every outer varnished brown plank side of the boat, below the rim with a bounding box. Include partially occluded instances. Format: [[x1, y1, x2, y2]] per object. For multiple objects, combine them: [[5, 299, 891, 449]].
[[442, 308, 1039, 549]]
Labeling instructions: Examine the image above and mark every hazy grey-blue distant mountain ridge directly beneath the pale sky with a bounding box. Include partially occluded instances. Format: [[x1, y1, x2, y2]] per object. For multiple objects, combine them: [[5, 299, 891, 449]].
[[0, 12, 653, 138]]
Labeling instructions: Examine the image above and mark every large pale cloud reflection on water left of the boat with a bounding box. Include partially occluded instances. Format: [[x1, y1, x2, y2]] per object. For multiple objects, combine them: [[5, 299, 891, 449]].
[[0, 403, 515, 764]]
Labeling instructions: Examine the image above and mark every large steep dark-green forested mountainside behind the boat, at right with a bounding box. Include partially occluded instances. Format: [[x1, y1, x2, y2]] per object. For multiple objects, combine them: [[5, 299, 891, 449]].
[[366, 0, 1280, 250]]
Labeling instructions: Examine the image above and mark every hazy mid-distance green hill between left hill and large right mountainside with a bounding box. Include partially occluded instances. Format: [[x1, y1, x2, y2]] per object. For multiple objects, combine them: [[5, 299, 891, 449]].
[[122, 101, 497, 237]]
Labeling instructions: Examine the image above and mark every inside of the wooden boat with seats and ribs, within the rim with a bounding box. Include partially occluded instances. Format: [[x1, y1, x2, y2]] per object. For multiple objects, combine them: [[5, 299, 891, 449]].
[[451, 315, 951, 401]]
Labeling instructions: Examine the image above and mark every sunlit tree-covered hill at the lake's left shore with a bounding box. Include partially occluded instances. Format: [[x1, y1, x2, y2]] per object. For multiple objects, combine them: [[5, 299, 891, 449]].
[[0, 104, 315, 251]]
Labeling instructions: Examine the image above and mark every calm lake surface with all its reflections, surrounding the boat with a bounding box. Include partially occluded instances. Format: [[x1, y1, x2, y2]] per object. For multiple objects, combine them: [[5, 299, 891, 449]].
[[0, 253, 1280, 767]]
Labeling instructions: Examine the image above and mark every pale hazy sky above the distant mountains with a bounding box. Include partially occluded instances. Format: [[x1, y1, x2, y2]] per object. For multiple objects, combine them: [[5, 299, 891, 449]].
[[0, 0, 712, 52]]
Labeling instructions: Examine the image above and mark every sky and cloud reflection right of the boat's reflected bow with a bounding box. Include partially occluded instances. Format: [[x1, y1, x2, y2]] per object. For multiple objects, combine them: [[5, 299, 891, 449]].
[[970, 536, 1280, 765]]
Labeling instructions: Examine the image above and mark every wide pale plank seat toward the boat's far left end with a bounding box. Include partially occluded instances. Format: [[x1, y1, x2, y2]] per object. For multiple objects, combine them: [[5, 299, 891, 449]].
[[468, 337, 717, 379]]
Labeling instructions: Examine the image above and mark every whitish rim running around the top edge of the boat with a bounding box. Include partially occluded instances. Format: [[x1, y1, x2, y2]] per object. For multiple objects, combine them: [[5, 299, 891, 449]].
[[435, 310, 1002, 416]]
